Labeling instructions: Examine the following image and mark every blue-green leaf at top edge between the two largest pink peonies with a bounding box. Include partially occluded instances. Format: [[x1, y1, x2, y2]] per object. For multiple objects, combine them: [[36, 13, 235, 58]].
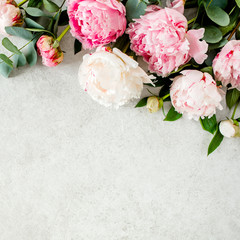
[[126, 0, 147, 22]]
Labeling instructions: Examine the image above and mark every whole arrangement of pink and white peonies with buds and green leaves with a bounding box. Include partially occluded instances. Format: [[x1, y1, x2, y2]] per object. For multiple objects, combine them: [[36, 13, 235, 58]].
[[0, 0, 240, 154]]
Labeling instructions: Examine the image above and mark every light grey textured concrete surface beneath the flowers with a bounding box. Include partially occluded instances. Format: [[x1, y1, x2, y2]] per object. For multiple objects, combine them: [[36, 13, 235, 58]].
[[0, 8, 240, 240]]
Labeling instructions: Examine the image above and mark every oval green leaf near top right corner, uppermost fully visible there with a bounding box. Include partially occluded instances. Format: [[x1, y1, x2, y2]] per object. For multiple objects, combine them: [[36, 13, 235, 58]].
[[206, 6, 230, 26]]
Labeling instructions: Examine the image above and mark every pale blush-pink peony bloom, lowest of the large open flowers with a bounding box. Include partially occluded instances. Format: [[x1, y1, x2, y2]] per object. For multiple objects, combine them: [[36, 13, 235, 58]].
[[170, 70, 223, 120]]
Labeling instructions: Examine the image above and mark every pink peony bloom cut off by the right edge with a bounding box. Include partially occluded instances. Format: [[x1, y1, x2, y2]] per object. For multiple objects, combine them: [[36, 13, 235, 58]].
[[213, 40, 240, 90]]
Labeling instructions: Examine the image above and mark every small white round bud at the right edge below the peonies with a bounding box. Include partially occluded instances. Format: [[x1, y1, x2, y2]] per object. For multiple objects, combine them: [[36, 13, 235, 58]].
[[219, 120, 240, 138]]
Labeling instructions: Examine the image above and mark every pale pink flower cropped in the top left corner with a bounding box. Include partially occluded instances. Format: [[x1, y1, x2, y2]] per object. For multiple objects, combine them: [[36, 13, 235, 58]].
[[0, 0, 23, 35]]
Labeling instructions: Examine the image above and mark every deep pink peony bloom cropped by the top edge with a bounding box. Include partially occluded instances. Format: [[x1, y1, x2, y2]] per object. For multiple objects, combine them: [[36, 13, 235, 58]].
[[68, 0, 127, 49]]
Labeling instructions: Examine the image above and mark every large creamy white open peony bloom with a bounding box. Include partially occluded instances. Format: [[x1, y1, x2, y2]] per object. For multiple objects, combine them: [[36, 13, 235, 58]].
[[78, 48, 154, 108]]
